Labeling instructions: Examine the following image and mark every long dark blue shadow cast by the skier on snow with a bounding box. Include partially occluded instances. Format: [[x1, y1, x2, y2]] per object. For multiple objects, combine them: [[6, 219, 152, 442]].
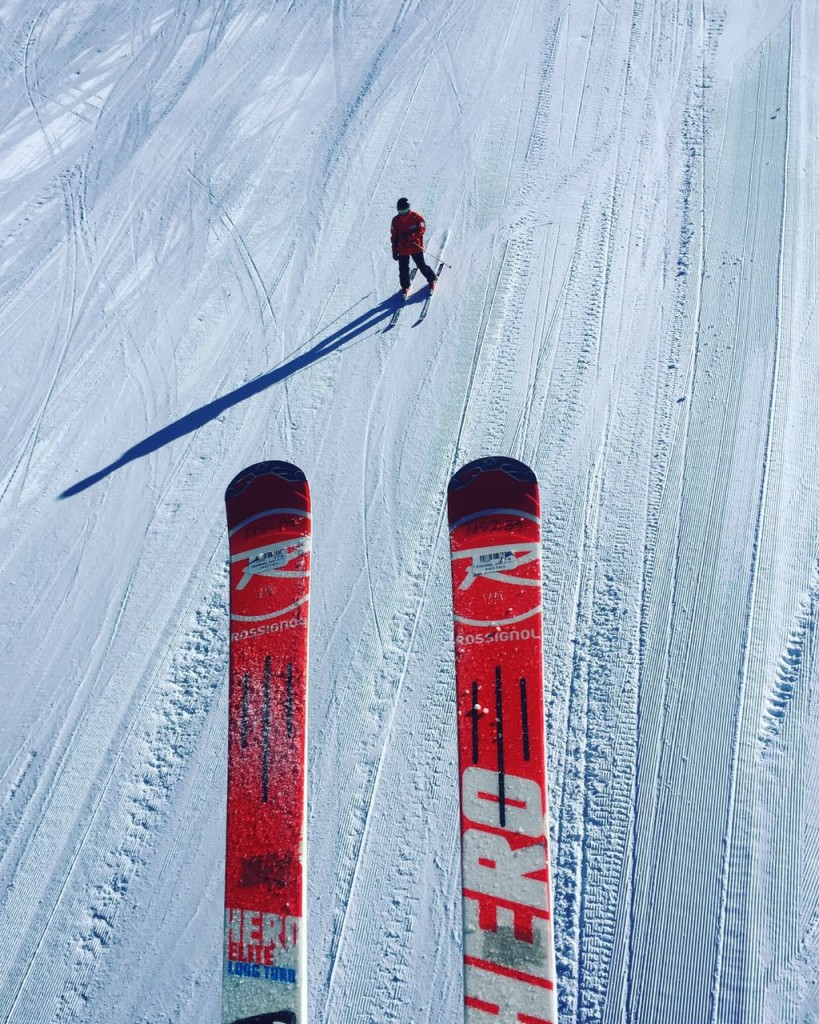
[[59, 296, 400, 499]]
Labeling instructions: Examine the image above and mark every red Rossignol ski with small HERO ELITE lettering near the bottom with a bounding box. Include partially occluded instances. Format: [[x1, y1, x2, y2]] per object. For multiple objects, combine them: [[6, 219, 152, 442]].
[[222, 462, 310, 1024]]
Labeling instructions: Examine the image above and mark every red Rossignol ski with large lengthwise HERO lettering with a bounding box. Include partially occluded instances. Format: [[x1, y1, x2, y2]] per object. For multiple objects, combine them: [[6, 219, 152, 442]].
[[448, 458, 557, 1024]]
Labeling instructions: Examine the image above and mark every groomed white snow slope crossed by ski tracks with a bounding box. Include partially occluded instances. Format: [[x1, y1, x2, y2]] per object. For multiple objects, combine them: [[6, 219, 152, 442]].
[[0, 0, 819, 1024]]
